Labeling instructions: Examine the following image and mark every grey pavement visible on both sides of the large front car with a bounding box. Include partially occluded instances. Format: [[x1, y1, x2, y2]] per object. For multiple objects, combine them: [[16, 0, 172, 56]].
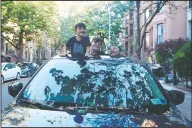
[[2, 78, 192, 121]]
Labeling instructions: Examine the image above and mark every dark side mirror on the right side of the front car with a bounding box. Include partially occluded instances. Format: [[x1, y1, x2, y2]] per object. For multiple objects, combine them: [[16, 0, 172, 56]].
[[169, 90, 185, 105]]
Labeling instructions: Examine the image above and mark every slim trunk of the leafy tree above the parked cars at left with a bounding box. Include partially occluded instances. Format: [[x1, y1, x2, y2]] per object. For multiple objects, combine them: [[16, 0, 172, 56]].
[[18, 29, 24, 63]]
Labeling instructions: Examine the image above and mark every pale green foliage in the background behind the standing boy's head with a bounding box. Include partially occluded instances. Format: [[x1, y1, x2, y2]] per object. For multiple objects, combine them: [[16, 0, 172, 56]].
[[61, 1, 132, 44]]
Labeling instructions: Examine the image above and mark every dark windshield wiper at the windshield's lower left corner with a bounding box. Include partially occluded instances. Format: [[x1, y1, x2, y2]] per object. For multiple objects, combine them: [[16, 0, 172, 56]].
[[19, 99, 61, 111]]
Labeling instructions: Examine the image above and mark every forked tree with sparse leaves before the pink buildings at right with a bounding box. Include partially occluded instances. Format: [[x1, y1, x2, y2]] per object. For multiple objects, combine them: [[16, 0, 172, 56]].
[[136, 1, 183, 60]]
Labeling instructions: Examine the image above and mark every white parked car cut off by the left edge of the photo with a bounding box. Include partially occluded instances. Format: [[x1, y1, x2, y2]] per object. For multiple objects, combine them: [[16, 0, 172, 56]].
[[1, 62, 21, 83]]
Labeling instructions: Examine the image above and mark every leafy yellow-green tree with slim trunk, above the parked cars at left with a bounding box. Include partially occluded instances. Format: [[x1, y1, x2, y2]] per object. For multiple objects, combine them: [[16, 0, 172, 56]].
[[2, 1, 59, 62]]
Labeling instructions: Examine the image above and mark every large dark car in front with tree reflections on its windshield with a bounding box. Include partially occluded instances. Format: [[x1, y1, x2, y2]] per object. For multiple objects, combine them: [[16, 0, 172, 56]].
[[2, 55, 191, 128]]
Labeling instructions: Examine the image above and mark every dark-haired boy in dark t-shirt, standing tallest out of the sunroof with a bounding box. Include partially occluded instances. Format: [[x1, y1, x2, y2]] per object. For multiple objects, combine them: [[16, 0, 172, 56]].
[[63, 23, 91, 58]]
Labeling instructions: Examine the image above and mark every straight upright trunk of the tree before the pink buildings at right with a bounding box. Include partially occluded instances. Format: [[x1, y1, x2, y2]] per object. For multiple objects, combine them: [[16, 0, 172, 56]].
[[135, 1, 141, 60]]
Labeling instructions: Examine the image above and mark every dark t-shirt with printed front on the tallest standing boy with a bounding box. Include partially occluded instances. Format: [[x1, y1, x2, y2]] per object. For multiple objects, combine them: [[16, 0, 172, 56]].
[[66, 36, 91, 57]]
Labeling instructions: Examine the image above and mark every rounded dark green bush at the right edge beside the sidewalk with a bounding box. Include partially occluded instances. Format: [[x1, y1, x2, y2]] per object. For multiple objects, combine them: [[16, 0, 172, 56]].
[[173, 42, 192, 77]]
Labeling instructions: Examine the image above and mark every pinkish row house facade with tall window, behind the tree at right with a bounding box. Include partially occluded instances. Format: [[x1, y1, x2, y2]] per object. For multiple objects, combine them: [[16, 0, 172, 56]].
[[122, 1, 189, 60]]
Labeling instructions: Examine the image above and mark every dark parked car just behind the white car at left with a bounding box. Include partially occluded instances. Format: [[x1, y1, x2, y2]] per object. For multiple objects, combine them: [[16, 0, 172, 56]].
[[17, 62, 39, 77]]
